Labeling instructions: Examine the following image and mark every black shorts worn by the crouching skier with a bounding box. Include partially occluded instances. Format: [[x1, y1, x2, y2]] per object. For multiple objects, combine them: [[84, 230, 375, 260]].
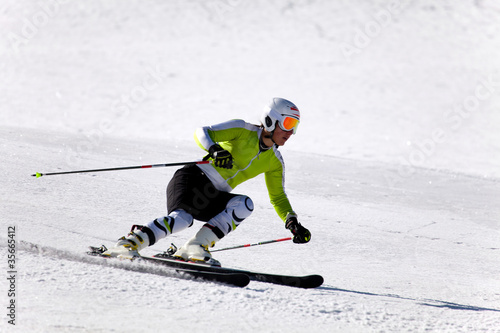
[[167, 165, 237, 222]]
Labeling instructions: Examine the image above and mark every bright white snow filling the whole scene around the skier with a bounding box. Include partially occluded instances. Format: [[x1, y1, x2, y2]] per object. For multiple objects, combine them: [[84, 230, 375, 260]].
[[0, 0, 500, 332]]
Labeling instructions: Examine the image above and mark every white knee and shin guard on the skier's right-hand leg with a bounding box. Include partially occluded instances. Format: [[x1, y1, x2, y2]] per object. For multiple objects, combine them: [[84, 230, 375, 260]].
[[205, 195, 253, 239]]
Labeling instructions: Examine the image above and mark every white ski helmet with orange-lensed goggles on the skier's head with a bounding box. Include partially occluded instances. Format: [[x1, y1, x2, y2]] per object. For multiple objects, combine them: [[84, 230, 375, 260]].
[[260, 97, 300, 134]]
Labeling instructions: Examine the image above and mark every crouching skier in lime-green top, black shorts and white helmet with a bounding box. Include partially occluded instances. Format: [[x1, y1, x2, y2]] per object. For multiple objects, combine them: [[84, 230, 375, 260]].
[[104, 98, 311, 266]]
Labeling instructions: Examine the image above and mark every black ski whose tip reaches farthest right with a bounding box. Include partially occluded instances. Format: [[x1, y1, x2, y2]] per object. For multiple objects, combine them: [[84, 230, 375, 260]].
[[150, 252, 324, 288]]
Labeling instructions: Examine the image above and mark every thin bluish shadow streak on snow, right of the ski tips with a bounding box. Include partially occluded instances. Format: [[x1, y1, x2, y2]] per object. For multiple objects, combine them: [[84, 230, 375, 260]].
[[316, 286, 500, 312]]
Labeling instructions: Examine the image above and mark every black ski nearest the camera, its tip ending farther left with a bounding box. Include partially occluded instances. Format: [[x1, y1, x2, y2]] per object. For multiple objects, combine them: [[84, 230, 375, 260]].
[[87, 245, 250, 287]]
